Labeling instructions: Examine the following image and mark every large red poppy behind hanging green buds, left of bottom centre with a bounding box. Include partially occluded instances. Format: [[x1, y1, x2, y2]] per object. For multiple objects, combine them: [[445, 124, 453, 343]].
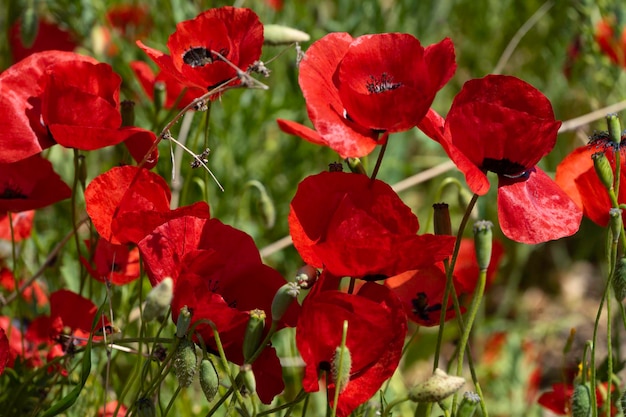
[[139, 216, 299, 403]]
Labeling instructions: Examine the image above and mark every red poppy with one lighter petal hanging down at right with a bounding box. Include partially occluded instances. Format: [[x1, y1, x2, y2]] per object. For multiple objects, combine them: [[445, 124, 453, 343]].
[[419, 75, 582, 243]]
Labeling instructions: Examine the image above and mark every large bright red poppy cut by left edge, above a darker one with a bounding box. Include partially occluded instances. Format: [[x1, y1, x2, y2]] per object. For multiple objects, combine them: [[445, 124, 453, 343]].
[[0, 51, 156, 163]]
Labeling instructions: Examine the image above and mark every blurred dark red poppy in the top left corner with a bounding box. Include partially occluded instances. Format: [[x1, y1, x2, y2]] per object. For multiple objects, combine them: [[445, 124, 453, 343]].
[[9, 19, 77, 63]]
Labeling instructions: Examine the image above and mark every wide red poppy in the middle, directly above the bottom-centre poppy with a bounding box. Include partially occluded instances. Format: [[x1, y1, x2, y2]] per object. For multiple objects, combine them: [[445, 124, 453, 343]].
[[289, 172, 454, 279]]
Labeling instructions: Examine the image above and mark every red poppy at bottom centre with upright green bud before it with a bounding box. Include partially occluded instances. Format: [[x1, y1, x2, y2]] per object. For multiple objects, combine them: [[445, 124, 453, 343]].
[[296, 274, 407, 417]]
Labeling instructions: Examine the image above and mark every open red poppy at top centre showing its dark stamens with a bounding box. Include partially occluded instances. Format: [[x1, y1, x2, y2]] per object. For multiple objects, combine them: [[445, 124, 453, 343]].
[[278, 33, 456, 158]]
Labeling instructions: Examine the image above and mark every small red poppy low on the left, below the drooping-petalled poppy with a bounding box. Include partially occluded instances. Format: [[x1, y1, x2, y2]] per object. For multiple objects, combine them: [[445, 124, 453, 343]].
[[80, 238, 140, 285]]
